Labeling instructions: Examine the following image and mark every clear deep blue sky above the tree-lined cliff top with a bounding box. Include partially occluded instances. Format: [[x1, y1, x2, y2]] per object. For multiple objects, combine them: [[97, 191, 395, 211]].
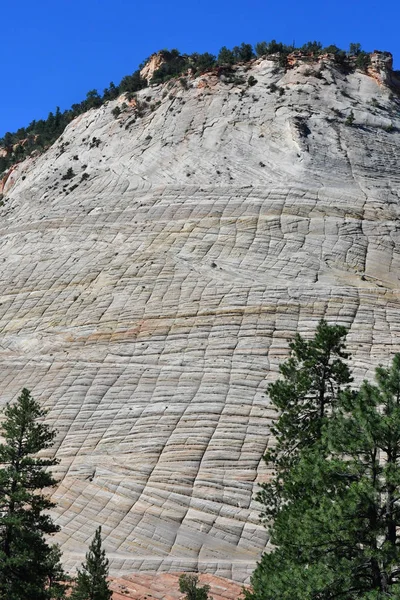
[[0, 0, 400, 136]]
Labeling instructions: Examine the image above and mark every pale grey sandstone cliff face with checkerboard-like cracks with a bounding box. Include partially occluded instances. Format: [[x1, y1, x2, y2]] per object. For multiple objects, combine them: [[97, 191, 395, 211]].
[[0, 59, 400, 581]]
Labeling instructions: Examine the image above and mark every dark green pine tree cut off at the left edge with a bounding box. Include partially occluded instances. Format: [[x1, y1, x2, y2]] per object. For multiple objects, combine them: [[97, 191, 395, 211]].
[[0, 389, 64, 600]]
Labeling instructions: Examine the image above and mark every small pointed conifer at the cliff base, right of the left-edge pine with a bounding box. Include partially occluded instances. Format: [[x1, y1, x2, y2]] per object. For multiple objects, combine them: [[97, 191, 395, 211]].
[[71, 527, 112, 600]]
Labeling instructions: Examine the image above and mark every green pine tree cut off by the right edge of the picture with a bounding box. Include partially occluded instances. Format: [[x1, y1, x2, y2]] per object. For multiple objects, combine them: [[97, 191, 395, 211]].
[[325, 354, 400, 598]]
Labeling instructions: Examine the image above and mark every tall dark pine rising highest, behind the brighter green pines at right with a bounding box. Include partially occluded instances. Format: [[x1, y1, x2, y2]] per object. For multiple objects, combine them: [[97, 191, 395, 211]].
[[257, 320, 352, 520]]
